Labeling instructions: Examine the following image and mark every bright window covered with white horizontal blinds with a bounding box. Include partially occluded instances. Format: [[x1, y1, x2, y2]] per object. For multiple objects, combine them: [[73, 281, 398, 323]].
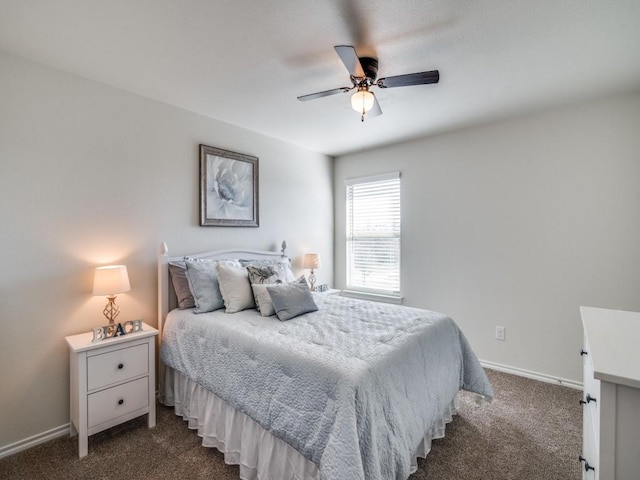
[[346, 172, 400, 296]]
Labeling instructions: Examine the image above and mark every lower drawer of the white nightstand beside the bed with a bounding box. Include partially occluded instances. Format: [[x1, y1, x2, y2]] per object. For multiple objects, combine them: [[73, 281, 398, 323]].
[[87, 377, 149, 428]]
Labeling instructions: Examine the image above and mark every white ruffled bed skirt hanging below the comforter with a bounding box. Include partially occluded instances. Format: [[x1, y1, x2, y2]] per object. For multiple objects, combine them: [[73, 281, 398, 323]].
[[164, 367, 458, 480]]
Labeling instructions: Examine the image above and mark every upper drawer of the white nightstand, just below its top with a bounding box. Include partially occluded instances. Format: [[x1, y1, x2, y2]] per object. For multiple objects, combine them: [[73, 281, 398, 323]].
[[87, 343, 149, 391]]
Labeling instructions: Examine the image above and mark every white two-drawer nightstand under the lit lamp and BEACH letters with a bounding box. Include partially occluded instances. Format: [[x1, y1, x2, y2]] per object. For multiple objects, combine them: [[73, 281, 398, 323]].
[[65, 323, 158, 458]]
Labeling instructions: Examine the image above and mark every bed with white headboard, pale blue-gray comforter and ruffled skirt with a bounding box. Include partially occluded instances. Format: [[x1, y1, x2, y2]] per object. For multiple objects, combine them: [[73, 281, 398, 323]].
[[158, 242, 493, 480]]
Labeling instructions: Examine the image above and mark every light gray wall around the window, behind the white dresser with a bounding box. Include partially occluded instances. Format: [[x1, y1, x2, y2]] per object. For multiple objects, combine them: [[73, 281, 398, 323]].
[[334, 95, 640, 381]]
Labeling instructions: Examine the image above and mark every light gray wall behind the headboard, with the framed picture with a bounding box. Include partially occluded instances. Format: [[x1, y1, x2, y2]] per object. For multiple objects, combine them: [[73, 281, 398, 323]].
[[0, 53, 333, 448]]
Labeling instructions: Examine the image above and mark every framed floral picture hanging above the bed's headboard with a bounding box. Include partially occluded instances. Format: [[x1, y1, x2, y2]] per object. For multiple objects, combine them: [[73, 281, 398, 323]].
[[200, 145, 260, 227]]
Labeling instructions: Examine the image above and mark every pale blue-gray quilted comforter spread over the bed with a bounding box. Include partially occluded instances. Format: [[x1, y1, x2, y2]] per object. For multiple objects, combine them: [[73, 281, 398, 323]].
[[161, 296, 493, 480]]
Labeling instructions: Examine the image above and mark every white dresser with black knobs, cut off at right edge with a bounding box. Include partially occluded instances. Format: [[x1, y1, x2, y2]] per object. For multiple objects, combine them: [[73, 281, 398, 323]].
[[580, 307, 640, 480]]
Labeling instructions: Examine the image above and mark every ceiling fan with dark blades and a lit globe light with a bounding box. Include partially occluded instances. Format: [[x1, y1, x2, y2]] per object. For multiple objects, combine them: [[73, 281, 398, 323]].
[[298, 45, 440, 122]]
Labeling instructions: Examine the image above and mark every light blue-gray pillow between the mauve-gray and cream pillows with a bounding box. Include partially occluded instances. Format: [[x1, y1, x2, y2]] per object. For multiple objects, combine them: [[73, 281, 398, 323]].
[[184, 257, 224, 313]]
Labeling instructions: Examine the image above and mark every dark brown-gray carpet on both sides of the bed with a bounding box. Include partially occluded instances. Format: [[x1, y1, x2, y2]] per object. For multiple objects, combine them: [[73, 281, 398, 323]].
[[0, 370, 582, 480]]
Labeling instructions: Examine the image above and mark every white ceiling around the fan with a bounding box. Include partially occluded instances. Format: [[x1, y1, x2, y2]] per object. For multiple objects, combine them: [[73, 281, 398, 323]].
[[0, 0, 640, 155]]
